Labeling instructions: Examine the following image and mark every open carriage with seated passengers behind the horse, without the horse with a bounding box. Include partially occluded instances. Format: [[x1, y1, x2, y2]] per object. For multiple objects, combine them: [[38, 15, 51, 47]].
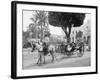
[[61, 41, 84, 57]]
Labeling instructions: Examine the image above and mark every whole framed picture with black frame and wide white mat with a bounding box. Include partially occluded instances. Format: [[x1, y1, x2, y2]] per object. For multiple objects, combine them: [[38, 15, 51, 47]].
[[12, 2, 97, 78]]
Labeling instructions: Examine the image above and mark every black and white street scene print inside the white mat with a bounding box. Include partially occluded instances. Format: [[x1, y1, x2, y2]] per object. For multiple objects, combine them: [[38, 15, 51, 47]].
[[22, 10, 91, 70]]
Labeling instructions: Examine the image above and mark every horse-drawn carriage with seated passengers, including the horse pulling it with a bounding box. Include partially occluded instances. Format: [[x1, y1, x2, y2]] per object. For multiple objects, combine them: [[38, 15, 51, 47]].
[[27, 37, 84, 64]]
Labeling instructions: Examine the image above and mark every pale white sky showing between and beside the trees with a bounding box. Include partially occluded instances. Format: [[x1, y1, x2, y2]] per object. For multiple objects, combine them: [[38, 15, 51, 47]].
[[23, 11, 91, 36]]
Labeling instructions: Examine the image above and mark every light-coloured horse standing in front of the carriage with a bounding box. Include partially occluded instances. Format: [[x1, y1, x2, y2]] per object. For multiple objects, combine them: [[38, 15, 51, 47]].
[[36, 43, 56, 64]]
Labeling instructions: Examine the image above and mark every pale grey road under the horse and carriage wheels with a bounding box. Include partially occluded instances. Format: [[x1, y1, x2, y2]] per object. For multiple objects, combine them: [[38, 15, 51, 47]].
[[22, 48, 91, 69]]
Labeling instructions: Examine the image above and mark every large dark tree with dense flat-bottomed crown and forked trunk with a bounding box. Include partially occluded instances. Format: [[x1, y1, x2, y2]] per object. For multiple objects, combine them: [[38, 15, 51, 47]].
[[49, 12, 85, 42]]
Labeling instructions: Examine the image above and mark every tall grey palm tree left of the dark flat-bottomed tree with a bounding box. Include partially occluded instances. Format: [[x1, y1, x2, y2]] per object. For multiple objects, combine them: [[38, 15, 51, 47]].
[[31, 11, 48, 40]]
